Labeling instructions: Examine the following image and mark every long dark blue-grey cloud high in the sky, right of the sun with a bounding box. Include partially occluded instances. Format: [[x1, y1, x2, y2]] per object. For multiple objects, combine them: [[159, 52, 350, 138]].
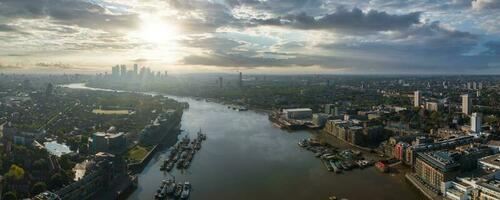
[[252, 7, 420, 31]]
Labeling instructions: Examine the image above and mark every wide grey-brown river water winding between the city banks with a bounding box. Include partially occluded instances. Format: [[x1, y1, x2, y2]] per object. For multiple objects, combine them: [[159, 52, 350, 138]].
[[62, 84, 422, 200]]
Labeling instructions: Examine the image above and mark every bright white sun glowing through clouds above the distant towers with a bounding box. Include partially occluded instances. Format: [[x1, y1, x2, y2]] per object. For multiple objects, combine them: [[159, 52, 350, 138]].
[[136, 15, 178, 44]]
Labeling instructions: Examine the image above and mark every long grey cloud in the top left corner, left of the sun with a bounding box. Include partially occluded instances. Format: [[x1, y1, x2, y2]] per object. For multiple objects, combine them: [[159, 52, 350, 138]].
[[0, 0, 139, 30]]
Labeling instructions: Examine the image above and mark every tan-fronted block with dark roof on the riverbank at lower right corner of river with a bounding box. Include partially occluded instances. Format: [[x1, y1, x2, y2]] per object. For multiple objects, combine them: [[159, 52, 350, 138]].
[[415, 151, 460, 191]]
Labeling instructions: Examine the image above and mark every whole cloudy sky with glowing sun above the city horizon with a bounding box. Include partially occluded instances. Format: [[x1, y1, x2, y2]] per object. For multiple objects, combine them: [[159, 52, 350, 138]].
[[0, 0, 500, 74]]
